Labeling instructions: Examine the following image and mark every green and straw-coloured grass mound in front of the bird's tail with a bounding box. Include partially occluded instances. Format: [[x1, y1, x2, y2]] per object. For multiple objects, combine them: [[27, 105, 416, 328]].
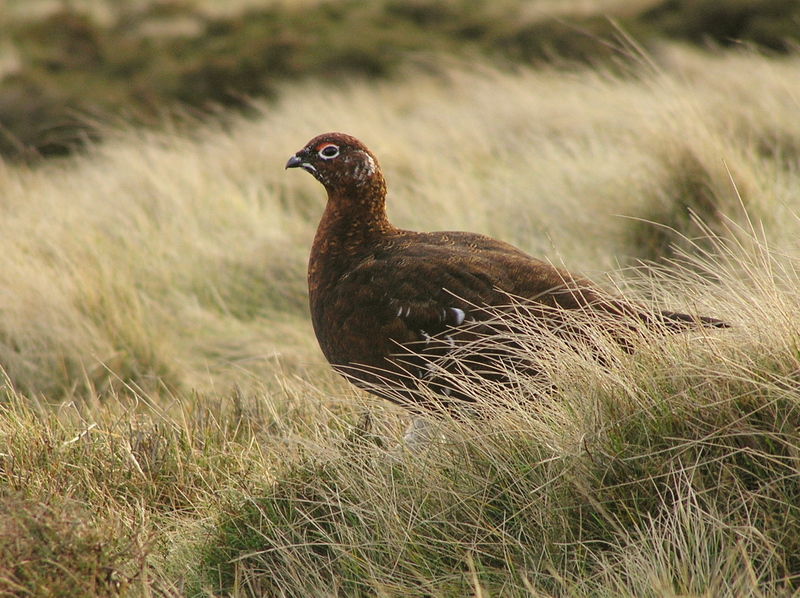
[[194, 247, 800, 596]]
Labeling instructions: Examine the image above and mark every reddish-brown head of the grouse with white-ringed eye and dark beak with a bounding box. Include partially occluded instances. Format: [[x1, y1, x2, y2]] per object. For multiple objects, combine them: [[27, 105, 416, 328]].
[[286, 133, 382, 191]]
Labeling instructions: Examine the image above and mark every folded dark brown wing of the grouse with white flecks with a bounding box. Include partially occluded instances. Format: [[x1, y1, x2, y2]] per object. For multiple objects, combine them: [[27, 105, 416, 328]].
[[320, 233, 600, 398]]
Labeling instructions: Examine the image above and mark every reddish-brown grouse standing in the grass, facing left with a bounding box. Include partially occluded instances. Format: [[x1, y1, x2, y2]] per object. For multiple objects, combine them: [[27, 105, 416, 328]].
[[286, 132, 728, 415]]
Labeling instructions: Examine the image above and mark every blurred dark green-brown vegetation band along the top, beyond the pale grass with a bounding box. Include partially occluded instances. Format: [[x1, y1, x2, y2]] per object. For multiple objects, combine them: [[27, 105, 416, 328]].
[[0, 0, 800, 162]]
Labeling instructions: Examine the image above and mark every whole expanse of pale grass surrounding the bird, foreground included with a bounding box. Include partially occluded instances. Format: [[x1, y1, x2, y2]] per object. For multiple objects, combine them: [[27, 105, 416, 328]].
[[0, 46, 800, 597]]
